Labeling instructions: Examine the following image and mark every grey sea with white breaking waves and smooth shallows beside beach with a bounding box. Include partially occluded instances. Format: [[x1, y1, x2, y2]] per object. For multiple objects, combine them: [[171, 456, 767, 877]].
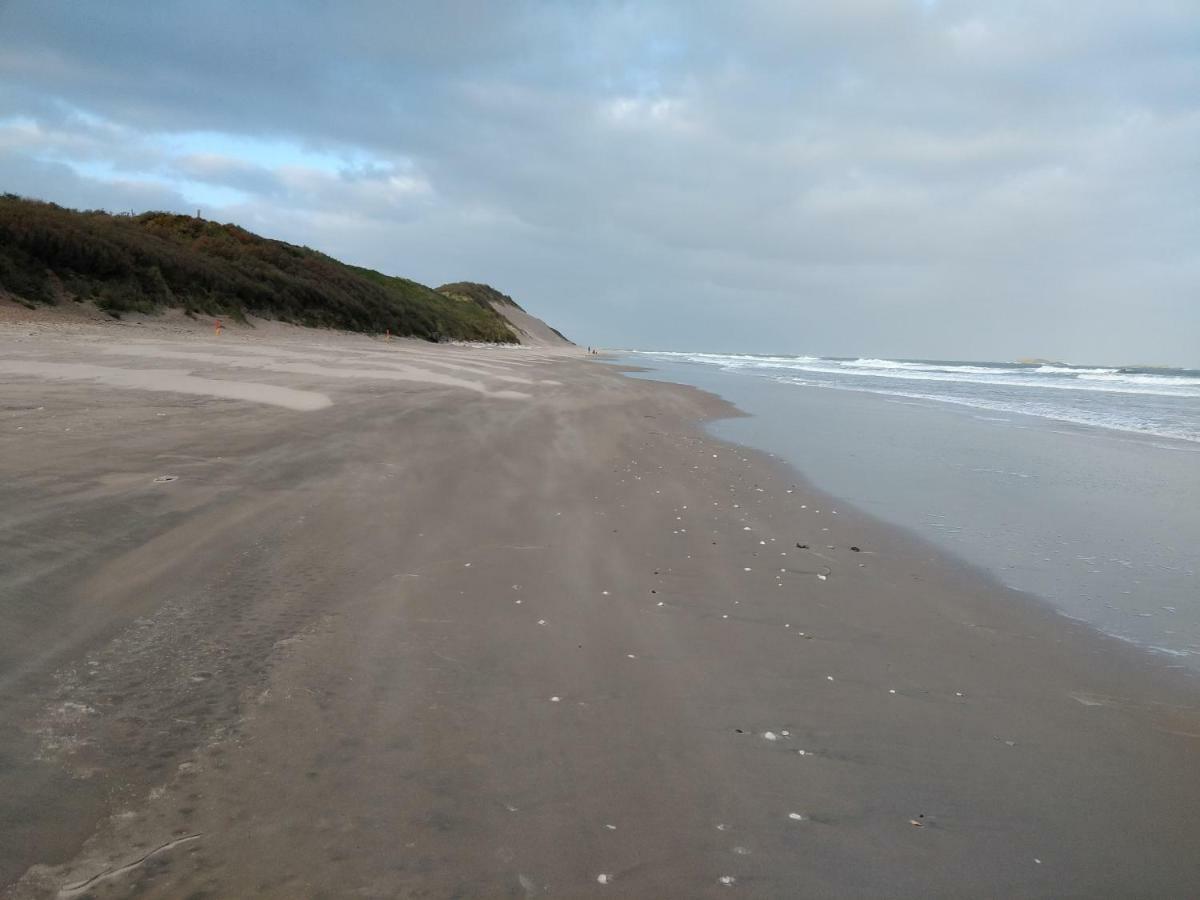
[[618, 350, 1200, 674]]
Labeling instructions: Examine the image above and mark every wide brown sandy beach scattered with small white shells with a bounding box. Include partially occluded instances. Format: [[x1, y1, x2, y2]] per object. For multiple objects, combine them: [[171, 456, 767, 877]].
[[0, 322, 1200, 898]]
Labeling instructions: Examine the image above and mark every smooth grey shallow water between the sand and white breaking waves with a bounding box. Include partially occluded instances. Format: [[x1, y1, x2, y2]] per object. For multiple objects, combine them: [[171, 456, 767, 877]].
[[619, 355, 1200, 673]]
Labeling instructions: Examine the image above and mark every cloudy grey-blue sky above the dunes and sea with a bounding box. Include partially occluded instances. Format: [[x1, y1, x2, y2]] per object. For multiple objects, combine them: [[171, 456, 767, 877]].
[[0, 0, 1200, 367]]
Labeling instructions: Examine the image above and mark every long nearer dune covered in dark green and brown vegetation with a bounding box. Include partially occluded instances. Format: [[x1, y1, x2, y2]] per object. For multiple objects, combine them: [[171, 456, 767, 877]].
[[0, 194, 517, 343]]
